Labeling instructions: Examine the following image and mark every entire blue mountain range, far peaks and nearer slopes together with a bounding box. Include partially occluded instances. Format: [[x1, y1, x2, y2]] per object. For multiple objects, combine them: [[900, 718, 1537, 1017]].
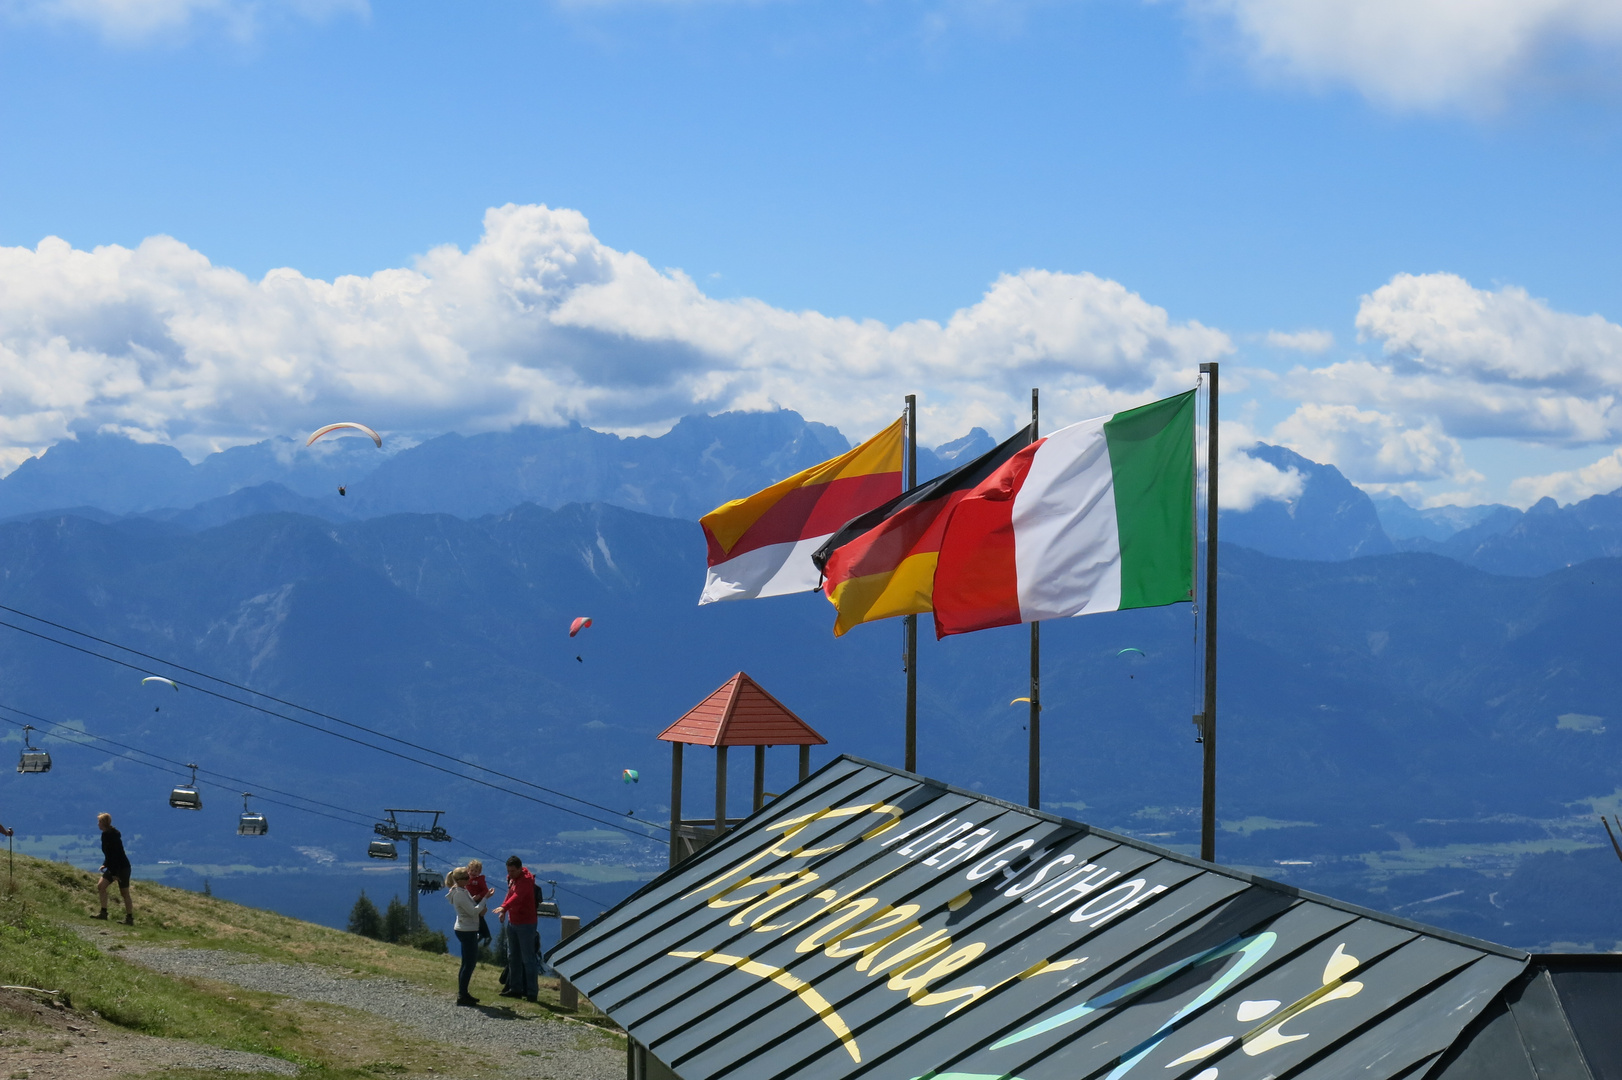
[[0, 414, 1622, 947]]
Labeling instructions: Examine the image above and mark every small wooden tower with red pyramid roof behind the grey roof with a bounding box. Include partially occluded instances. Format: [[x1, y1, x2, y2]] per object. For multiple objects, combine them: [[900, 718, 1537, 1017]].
[[659, 671, 827, 866]]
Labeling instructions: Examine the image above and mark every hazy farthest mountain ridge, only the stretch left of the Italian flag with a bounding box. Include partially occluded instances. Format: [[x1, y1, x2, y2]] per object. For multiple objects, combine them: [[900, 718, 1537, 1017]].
[[0, 410, 966, 527]]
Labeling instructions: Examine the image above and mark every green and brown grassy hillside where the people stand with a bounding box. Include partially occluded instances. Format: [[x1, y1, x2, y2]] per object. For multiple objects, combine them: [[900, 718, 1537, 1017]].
[[0, 856, 616, 1078]]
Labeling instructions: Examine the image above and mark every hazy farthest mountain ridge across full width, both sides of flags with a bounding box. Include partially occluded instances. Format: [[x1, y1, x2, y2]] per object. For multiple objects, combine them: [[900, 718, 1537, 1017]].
[[9, 410, 1622, 576]]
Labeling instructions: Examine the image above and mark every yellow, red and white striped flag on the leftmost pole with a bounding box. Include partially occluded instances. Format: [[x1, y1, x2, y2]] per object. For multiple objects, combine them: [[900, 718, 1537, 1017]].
[[699, 420, 902, 605]]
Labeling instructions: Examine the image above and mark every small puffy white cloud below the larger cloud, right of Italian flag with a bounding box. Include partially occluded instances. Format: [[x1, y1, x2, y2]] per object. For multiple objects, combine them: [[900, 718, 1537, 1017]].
[[1273, 402, 1481, 485]]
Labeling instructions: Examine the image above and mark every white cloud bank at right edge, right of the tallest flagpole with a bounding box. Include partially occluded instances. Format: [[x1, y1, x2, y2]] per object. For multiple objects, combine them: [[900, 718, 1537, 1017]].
[[1275, 274, 1622, 503]]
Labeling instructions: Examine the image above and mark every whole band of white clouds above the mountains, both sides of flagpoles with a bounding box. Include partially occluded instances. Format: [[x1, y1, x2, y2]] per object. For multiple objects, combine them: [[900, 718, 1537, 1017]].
[[9, 206, 1622, 506]]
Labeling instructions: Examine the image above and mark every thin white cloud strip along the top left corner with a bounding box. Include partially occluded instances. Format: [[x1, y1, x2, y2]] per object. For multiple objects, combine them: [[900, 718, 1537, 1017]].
[[0, 0, 370, 44]]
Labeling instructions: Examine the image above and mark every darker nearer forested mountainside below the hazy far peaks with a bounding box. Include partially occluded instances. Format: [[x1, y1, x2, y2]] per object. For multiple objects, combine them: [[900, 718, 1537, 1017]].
[[0, 504, 1622, 942]]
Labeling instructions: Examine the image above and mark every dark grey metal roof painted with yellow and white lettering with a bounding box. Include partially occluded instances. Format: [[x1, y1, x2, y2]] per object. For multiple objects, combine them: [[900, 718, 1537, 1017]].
[[550, 757, 1526, 1080]]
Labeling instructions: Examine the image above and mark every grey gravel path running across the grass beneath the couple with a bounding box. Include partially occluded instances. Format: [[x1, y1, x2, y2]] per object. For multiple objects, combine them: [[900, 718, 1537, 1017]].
[[118, 947, 624, 1080]]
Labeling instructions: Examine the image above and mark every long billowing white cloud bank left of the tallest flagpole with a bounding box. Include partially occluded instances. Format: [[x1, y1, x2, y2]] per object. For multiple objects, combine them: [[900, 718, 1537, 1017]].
[[0, 206, 1231, 461]]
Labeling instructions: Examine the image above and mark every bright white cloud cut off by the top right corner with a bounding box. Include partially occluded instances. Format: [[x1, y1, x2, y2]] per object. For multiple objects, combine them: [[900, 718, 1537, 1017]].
[[1186, 0, 1622, 110]]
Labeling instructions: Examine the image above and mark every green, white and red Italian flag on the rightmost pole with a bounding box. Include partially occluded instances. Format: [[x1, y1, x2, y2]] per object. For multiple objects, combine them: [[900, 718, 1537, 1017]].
[[933, 391, 1195, 637]]
